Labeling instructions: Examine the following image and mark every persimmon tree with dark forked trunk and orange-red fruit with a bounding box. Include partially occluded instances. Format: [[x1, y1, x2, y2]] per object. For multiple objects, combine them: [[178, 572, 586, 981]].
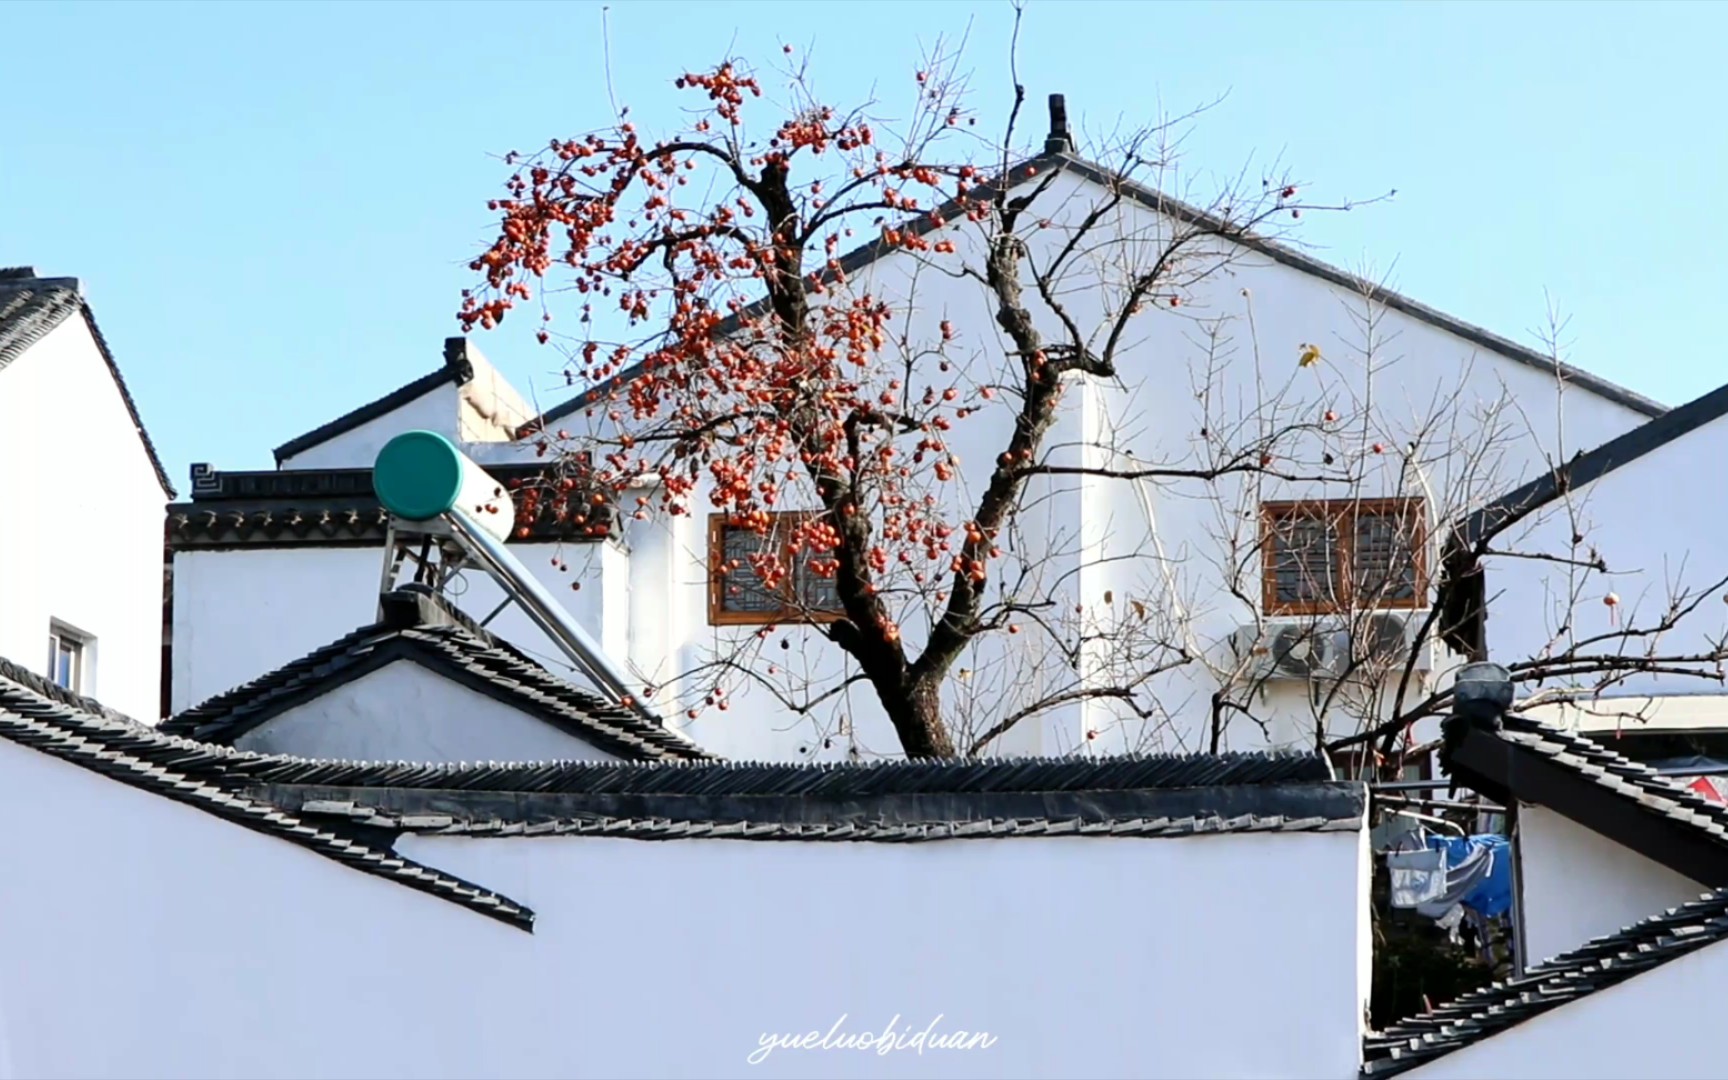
[[461, 29, 1361, 757]]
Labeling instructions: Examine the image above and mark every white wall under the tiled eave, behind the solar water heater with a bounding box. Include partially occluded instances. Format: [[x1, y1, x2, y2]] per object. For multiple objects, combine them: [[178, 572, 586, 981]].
[[173, 544, 626, 712]]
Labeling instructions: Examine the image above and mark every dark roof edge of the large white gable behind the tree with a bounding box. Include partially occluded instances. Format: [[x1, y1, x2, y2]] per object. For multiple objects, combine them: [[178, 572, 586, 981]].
[[518, 148, 1668, 435]]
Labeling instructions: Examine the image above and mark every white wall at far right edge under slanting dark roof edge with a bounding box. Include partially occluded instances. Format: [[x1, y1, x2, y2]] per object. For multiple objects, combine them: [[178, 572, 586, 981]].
[[1488, 406, 1728, 695]]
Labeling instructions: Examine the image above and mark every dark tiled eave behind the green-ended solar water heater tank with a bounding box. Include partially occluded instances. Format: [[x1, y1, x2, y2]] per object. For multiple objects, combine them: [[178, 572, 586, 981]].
[[166, 461, 613, 551]]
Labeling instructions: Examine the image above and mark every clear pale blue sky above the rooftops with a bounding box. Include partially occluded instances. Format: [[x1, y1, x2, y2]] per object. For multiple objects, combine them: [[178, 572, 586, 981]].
[[0, 0, 1728, 491]]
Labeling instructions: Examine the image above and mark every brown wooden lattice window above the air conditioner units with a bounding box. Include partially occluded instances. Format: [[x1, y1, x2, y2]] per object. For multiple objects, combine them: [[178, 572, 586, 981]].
[[1260, 499, 1427, 615]]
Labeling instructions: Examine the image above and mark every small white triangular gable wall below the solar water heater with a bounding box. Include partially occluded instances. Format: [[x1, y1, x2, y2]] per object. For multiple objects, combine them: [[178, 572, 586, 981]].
[[235, 660, 617, 762]]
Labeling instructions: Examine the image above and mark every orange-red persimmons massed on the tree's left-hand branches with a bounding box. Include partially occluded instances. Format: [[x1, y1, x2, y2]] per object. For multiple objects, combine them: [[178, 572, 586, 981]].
[[458, 62, 1001, 656]]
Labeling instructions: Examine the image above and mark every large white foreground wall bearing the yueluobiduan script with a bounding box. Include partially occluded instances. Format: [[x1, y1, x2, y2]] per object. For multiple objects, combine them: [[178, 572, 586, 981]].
[[0, 743, 1367, 1080]]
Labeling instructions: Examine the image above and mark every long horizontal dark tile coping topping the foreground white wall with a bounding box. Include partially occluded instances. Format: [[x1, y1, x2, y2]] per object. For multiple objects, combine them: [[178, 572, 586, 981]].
[[230, 755, 1367, 843]]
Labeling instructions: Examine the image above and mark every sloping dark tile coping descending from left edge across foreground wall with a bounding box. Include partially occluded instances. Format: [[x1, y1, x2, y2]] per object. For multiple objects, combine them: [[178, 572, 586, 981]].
[[0, 660, 534, 930]]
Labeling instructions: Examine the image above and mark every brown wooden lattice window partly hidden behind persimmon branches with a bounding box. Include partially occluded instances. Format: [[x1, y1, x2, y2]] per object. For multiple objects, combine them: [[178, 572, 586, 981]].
[[708, 510, 840, 626]]
